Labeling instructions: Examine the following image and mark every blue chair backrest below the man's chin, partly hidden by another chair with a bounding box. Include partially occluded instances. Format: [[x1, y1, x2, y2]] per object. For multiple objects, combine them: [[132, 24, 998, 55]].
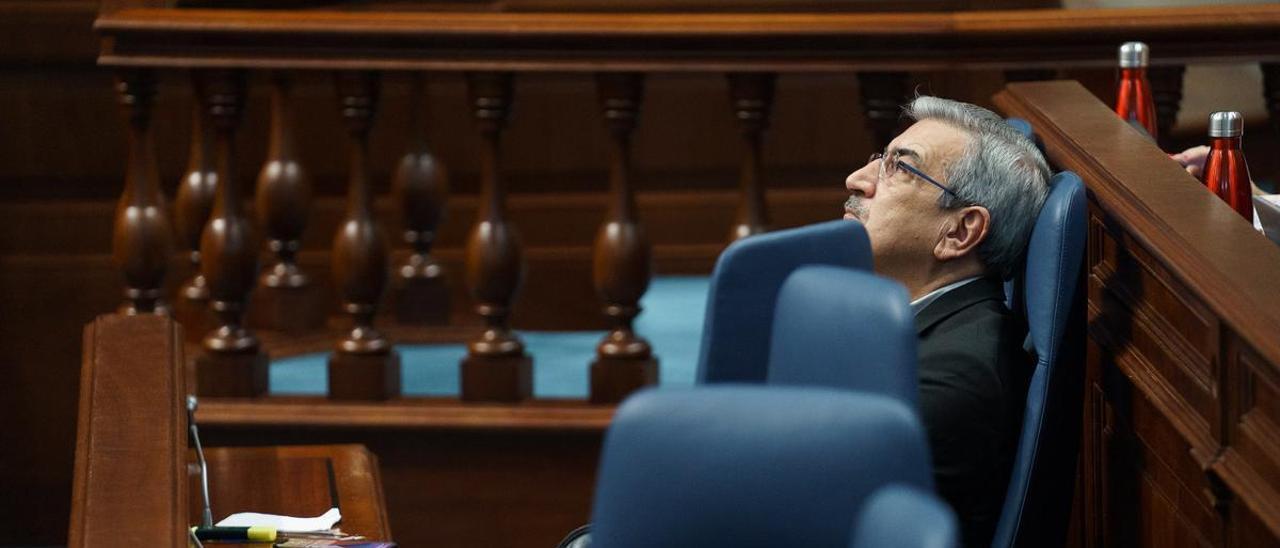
[[698, 220, 872, 383]]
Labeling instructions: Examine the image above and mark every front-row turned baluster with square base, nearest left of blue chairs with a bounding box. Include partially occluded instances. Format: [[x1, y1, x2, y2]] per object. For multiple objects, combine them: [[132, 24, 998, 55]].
[[590, 73, 658, 403]]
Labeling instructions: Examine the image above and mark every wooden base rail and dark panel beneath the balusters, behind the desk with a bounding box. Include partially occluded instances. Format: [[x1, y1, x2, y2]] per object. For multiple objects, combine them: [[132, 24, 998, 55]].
[[197, 398, 613, 548]]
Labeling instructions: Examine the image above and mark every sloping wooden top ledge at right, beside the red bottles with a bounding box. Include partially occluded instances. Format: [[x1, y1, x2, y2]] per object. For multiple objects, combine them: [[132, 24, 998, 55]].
[[996, 82, 1280, 371]]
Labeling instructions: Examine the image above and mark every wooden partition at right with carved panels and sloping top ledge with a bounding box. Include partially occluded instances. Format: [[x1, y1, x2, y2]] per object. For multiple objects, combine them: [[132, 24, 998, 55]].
[[997, 82, 1280, 547]]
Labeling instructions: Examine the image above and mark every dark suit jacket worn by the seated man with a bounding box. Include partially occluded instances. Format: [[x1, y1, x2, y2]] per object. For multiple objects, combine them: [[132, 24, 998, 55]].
[[915, 278, 1032, 548]]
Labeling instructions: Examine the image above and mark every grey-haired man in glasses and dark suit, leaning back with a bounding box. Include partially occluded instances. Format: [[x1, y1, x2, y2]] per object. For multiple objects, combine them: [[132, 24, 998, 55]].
[[845, 96, 1050, 547]]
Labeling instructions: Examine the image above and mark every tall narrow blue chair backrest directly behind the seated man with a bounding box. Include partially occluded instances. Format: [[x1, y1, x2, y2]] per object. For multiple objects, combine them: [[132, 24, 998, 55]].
[[992, 172, 1087, 547]]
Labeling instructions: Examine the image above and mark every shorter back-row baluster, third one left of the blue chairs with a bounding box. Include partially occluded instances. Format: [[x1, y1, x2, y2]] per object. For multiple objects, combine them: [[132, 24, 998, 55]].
[[392, 74, 449, 324]]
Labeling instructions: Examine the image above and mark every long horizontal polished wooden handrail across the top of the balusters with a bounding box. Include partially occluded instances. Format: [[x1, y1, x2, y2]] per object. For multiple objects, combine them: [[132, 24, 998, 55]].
[[95, 5, 1280, 72]]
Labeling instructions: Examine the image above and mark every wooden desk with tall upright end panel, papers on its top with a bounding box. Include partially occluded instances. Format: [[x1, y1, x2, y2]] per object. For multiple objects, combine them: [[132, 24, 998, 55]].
[[68, 315, 390, 548]]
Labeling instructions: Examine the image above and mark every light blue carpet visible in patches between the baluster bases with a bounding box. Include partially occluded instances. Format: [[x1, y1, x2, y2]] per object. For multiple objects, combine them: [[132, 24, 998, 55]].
[[270, 277, 709, 398]]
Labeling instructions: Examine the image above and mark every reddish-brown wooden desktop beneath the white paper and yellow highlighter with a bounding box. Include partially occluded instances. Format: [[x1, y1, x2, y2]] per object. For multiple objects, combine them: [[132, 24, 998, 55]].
[[187, 446, 390, 545]]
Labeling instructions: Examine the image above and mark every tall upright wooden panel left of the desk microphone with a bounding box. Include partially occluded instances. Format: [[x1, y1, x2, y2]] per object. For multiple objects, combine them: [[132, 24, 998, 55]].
[[68, 315, 187, 547]]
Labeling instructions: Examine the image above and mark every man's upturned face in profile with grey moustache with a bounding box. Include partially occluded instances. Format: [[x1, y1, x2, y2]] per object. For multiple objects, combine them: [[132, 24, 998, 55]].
[[845, 120, 969, 274]]
